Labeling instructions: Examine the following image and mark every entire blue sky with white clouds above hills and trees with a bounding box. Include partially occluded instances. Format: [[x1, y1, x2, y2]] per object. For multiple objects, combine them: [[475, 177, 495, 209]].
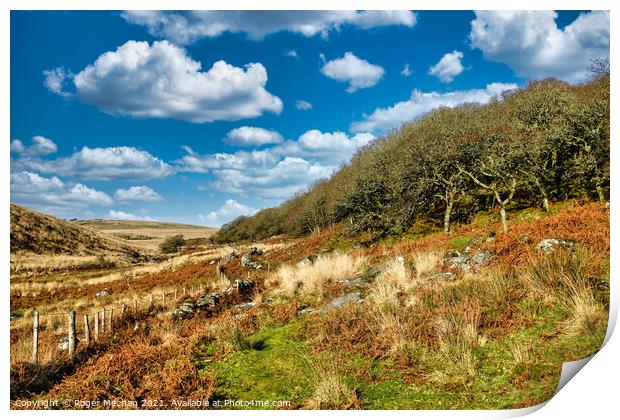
[[10, 11, 609, 226]]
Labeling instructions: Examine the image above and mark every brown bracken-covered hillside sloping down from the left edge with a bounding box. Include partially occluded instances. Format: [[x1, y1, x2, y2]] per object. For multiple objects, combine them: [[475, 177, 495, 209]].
[[11, 204, 143, 256]]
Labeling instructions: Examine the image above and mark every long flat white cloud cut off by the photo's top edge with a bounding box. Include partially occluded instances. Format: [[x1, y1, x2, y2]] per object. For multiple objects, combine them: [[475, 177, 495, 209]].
[[122, 10, 416, 44]]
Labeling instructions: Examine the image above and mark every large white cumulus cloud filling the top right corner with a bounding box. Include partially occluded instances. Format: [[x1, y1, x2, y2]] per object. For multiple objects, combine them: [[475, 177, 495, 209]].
[[469, 10, 609, 82]]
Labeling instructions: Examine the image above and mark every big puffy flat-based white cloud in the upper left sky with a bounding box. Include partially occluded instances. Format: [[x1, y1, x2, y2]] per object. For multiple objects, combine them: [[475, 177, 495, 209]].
[[46, 41, 282, 123]]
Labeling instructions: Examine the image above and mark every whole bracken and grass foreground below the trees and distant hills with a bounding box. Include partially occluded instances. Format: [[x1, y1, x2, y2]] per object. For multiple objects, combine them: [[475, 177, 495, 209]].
[[11, 202, 610, 409]]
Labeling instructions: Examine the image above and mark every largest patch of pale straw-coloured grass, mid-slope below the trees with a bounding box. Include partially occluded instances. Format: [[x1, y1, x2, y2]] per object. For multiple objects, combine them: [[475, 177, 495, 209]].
[[268, 254, 366, 297]]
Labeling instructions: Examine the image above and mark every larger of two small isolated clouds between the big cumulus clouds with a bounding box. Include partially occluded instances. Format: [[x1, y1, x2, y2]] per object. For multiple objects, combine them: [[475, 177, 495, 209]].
[[321, 51, 385, 93]]
